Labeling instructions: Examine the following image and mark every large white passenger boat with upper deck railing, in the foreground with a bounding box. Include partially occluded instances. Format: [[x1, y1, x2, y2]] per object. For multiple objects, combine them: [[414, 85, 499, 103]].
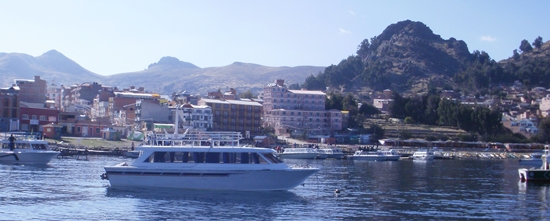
[[102, 132, 319, 191]]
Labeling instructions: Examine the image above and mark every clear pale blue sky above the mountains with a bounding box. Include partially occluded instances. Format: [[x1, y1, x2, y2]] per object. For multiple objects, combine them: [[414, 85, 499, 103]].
[[0, 0, 550, 75]]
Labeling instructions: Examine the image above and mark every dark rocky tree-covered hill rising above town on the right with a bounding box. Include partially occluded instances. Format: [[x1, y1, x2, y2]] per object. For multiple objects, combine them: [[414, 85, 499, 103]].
[[304, 20, 550, 94]]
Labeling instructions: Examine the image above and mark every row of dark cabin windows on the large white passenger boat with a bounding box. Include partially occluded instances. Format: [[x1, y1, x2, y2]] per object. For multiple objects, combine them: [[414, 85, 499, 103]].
[[144, 151, 282, 164]]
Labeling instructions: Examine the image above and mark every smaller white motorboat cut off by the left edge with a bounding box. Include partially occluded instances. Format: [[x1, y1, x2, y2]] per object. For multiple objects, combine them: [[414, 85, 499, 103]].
[[0, 135, 60, 164]]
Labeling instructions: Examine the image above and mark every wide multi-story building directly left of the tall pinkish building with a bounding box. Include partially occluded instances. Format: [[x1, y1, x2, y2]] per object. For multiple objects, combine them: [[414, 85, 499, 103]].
[[198, 98, 262, 138]]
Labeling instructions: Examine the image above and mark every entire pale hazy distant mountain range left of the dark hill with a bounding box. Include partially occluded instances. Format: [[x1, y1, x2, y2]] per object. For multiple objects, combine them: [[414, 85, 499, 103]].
[[0, 50, 324, 95]]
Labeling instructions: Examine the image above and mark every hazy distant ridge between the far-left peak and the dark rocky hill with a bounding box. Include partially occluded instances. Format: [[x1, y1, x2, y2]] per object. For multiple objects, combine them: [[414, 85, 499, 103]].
[[103, 57, 324, 95]]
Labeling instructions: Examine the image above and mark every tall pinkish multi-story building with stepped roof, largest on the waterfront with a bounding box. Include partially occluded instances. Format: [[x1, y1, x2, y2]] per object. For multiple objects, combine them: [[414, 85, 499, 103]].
[[263, 80, 343, 136]]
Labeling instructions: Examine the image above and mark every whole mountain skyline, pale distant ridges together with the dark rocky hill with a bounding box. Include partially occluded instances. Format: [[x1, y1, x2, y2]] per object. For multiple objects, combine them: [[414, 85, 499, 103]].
[[0, 20, 550, 94]]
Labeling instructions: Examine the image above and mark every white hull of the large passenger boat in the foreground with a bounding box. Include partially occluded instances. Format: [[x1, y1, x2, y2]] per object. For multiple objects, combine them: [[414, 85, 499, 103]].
[[105, 166, 319, 191]]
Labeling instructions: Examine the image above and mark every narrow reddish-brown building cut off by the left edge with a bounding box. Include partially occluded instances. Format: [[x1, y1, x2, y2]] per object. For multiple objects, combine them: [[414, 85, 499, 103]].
[[0, 86, 20, 132]]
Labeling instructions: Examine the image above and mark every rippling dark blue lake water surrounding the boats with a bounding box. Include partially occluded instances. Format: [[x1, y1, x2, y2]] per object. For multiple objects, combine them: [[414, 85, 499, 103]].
[[0, 156, 550, 220]]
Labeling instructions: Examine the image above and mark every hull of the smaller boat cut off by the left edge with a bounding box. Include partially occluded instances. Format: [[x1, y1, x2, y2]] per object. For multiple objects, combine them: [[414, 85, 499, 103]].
[[0, 150, 59, 164]]
